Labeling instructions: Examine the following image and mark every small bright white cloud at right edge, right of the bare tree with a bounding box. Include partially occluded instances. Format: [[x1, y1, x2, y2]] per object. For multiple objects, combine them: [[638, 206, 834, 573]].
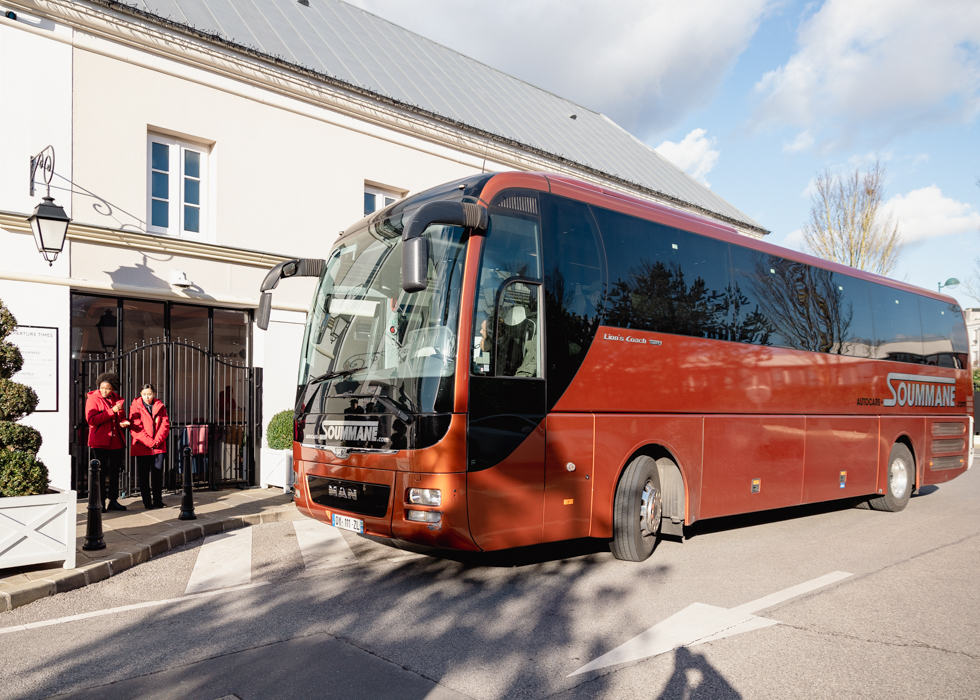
[[885, 185, 980, 243]]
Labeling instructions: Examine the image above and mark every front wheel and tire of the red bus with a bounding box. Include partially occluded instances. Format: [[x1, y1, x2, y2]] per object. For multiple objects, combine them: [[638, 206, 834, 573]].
[[609, 456, 663, 561]]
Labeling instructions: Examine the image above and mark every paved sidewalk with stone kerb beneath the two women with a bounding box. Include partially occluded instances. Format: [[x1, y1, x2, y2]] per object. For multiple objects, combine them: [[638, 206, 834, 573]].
[[0, 489, 303, 612]]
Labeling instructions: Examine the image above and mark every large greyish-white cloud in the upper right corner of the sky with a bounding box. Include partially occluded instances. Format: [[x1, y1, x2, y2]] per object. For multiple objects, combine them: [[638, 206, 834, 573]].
[[754, 0, 980, 141]]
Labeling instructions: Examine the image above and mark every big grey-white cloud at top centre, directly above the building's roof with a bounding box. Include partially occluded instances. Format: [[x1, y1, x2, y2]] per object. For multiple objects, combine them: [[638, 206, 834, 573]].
[[351, 0, 782, 139]]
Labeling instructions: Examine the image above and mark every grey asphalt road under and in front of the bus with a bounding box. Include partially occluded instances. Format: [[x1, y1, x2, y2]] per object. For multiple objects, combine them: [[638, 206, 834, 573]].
[[0, 469, 980, 700]]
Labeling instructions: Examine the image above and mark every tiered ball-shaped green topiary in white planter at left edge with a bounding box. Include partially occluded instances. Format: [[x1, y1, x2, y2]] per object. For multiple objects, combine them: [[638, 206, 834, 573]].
[[0, 301, 48, 497]]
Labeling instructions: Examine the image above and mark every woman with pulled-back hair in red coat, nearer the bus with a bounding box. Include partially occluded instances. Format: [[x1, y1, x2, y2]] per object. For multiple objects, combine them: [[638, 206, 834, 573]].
[[129, 384, 170, 510]]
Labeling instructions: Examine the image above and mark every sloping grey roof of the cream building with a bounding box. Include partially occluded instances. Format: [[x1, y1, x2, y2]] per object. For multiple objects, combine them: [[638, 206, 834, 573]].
[[120, 0, 765, 231]]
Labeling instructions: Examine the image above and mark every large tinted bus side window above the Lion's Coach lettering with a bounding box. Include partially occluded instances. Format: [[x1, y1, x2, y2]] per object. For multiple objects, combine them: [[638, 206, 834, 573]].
[[593, 209, 738, 340]]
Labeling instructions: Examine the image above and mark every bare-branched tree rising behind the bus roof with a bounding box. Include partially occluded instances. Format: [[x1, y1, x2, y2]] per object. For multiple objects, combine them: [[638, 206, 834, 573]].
[[803, 161, 902, 276]]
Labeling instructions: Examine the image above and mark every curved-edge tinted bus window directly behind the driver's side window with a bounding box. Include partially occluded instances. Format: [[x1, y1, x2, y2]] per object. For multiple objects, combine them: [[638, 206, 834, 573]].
[[541, 194, 605, 406]]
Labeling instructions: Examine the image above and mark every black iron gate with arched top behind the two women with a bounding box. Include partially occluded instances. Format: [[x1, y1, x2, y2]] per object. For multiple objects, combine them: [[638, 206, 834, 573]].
[[71, 338, 257, 496]]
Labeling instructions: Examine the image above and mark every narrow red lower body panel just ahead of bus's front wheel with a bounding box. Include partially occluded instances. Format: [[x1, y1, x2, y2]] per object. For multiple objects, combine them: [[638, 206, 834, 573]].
[[543, 413, 595, 542]]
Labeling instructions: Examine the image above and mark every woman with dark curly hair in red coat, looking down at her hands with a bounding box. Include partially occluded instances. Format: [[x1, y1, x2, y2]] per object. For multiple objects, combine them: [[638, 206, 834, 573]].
[[85, 372, 129, 512]]
